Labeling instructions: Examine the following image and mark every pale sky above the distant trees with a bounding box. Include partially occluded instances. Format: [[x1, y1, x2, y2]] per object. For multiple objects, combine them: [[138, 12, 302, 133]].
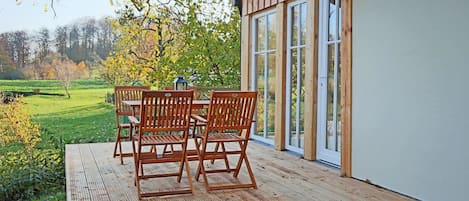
[[0, 0, 116, 33]]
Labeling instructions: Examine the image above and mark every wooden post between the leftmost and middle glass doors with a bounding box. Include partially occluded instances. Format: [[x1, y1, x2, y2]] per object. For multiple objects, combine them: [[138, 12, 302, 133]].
[[274, 3, 287, 150]]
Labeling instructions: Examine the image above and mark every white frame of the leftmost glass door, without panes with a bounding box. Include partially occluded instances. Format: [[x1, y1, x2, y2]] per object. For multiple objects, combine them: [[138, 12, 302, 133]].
[[251, 9, 278, 145]]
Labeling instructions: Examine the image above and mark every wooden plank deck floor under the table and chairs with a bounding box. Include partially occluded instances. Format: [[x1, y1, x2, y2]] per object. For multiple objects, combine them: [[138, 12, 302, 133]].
[[66, 142, 411, 201]]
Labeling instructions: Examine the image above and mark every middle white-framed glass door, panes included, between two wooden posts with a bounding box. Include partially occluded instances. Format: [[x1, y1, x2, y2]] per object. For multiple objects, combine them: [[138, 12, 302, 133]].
[[285, 0, 307, 154]]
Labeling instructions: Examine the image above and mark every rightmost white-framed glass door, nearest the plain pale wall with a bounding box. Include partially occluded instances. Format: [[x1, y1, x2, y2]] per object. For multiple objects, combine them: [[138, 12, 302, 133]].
[[317, 0, 342, 165]]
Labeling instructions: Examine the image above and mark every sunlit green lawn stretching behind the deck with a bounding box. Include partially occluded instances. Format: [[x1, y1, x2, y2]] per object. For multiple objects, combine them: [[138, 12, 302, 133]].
[[0, 80, 115, 143]]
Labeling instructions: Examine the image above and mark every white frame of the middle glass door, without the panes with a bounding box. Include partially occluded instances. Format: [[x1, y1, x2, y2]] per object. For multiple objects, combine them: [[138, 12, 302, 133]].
[[285, 0, 308, 154]]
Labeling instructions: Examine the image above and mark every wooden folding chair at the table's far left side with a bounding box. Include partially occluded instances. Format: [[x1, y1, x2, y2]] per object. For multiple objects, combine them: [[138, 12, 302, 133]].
[[113, 86, 150, 164]]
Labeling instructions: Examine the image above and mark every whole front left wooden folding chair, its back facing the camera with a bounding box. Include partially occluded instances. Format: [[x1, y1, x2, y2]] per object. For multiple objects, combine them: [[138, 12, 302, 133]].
[[131, 91, 193, 199]]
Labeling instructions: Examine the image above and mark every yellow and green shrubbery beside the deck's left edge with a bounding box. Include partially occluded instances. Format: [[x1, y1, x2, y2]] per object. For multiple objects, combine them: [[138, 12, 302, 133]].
[[0, 97, 65, 200]]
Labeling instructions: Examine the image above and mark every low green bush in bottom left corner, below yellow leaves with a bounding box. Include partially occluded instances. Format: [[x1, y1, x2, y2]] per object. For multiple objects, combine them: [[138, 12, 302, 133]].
[[0, 149, 65, 200]]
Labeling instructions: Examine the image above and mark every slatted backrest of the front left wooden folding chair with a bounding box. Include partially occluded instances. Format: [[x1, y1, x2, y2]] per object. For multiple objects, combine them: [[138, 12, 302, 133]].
[[140, 90, 193, 132]]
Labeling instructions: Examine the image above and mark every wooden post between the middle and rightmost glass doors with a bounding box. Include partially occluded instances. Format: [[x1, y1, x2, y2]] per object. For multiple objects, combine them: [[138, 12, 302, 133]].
[[304, 0, 319, 160]]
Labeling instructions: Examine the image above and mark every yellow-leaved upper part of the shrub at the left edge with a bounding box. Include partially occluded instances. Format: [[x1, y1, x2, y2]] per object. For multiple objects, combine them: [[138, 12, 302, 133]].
[[0, 97, 41, 151]]
